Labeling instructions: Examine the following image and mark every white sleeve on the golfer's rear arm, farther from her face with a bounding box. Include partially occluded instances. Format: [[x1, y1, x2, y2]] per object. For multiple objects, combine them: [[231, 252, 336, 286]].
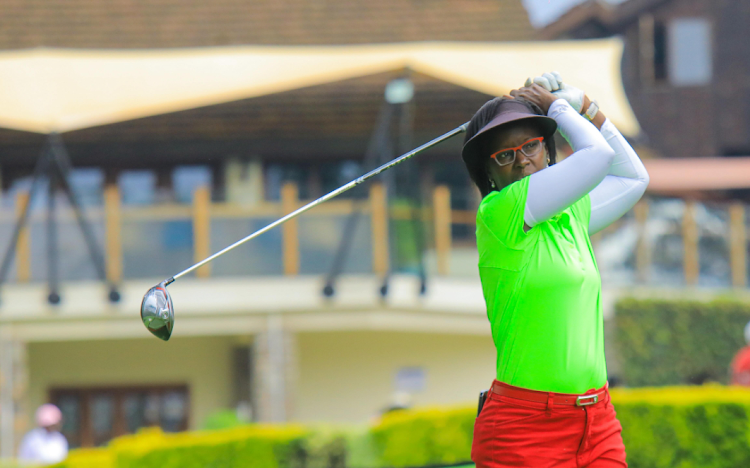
[[589, 119, 649, 234]]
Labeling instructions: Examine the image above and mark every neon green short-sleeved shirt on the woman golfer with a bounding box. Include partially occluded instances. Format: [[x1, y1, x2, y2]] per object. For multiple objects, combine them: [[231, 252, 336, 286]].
[[477, 177, 607, 393]]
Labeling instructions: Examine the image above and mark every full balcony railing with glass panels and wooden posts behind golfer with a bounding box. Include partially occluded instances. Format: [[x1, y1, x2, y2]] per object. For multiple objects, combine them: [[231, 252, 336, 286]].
[[0, 183, 748, 287]]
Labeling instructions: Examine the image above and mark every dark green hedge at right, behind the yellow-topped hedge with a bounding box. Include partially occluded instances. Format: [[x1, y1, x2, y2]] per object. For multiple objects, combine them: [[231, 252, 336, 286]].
[[614, 299, 750, 387]]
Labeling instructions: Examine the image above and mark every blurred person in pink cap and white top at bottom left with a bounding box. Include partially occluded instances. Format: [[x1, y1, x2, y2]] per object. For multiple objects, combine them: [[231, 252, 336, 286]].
[[18, 403, 68, 464]]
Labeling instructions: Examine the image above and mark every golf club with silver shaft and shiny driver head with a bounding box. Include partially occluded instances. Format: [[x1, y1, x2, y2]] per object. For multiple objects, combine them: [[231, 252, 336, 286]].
[[141, 122, 469, 341]]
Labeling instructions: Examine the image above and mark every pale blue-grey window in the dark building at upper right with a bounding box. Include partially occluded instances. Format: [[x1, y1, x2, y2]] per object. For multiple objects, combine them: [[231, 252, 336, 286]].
[[667, 18, 713, 86]]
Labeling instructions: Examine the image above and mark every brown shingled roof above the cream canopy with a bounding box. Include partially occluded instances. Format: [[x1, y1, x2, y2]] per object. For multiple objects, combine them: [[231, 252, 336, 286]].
[[0, 0, 535, 49]]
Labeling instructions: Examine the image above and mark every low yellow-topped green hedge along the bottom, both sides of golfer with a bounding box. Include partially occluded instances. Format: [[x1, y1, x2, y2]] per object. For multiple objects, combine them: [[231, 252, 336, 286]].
[[51, 385, 750, 468]]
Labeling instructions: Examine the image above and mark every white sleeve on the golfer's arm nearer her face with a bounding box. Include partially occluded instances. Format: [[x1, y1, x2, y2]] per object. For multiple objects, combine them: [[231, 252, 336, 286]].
[[523, 99, 615, 227]]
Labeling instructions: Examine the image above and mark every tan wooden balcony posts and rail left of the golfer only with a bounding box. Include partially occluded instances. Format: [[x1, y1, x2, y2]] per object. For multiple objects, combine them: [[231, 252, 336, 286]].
[[4, 183, 464, 282]]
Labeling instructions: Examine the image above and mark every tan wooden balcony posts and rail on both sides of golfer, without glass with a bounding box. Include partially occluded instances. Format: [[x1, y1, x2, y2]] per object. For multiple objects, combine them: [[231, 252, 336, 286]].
[[3, 183, 748, 287]]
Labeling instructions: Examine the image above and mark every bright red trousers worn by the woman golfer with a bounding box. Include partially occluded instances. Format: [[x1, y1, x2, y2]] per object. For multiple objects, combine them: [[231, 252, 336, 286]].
[[471, 381, 628, 468]]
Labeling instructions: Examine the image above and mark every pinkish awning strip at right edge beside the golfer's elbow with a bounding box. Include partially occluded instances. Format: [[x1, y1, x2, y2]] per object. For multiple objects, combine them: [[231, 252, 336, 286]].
[[643, 157, 750, 192]]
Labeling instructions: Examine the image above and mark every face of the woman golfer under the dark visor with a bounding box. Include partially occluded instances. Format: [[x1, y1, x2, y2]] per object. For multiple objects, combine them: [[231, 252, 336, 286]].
[[486, 122, 549, 193]]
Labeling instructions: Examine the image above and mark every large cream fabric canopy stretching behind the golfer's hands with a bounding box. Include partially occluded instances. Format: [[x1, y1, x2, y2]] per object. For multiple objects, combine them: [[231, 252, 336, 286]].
[[0, 39, 639, 135]]
